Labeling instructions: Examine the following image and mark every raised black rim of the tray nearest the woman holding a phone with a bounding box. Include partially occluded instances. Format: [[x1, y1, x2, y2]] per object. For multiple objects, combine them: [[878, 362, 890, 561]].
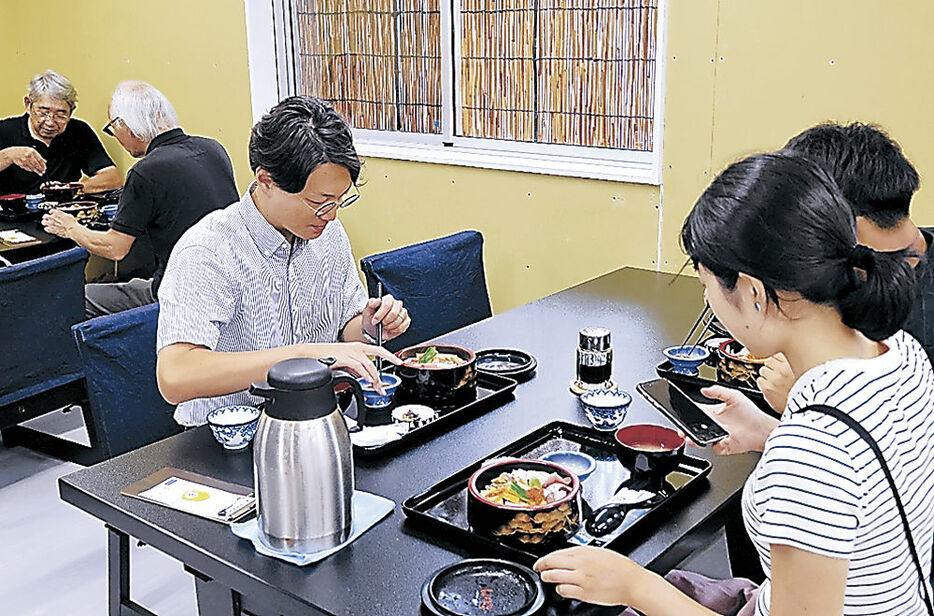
[[402, 420, 713, 566]]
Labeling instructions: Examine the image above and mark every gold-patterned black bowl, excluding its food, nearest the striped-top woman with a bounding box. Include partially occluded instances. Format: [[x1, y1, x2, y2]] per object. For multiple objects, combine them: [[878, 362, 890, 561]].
[[467, 459, 581, 548]]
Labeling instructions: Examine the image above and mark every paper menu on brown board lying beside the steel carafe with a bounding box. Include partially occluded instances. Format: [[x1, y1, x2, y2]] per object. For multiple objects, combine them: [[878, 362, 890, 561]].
[[121, 467, 256, 522]]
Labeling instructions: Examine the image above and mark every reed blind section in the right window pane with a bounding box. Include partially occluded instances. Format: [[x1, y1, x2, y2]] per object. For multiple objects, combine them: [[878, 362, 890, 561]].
[[460, 0, 658, 151]]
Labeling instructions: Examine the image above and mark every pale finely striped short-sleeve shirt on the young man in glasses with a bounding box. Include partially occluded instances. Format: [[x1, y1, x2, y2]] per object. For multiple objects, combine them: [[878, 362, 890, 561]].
[[156, 185, 366, 426]]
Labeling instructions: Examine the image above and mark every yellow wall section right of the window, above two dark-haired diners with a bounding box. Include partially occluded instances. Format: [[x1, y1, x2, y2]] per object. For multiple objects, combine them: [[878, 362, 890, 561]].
[[661, 0, 934, 270]]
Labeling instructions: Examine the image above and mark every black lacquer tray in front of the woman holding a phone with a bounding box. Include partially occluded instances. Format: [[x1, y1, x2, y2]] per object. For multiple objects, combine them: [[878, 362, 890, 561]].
[[402, 421, 711, 565]]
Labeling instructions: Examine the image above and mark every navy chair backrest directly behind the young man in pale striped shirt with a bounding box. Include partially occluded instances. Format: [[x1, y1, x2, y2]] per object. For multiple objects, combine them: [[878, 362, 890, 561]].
[[72, 304, 181, 457]]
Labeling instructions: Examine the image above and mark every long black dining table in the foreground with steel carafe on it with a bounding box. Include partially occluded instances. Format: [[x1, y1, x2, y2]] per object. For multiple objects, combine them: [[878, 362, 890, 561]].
[[59, 268, 757, 616]]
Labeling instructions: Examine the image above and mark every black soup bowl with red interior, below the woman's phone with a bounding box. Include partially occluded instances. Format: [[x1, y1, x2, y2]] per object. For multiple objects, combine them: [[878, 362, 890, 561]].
[[615, 424, 684, 477]]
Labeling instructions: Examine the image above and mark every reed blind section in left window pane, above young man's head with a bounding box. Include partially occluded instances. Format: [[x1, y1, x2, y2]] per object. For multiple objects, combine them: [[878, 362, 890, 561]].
[[292, 0, 441, 133]]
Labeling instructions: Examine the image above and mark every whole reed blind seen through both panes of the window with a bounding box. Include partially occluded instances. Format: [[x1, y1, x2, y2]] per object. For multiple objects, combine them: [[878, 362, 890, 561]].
[[292, 0, 658, 152]]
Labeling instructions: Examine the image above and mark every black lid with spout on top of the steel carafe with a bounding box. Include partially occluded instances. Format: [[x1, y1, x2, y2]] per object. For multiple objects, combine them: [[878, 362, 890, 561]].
[[250, 357, 337, 421]]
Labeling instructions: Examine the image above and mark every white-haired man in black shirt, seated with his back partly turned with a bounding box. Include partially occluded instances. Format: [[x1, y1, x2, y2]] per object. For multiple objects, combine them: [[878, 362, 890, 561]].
[[42, 81, 239, 317]]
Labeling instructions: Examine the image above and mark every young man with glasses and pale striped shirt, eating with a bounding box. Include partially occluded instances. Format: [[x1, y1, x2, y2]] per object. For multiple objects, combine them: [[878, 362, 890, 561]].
[[156, 96, 411, 426]]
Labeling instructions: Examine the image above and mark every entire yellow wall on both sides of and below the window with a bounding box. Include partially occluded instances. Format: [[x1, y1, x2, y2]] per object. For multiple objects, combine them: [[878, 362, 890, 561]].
[[0, 0, 934, 311]]
